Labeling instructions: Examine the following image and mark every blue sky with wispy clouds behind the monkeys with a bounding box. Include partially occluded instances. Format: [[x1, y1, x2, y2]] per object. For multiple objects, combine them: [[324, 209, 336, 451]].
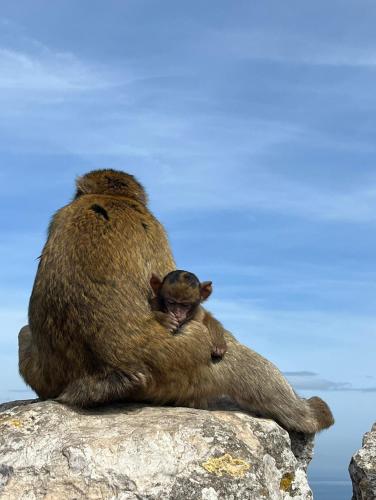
[[0, 0, 376, 492]]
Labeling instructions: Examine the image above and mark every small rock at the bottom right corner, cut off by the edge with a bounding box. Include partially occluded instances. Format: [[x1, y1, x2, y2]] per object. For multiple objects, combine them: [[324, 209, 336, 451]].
[[349, 423, 376, 500]]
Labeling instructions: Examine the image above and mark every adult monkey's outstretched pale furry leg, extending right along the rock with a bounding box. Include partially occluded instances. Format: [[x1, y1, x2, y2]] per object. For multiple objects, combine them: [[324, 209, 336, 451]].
[[142, 323, 334, 433]]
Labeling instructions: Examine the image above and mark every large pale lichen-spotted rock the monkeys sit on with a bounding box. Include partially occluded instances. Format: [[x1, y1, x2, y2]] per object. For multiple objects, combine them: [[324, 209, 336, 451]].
[[0, 401, 313, 500]]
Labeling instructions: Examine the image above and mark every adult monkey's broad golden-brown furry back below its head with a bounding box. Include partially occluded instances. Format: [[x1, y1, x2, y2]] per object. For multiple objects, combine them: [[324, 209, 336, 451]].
[[29, 195, 175, 394]]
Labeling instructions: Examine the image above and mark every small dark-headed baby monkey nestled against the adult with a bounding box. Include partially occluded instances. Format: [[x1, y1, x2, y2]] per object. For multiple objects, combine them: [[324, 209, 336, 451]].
[[150, 270, 227, 358]]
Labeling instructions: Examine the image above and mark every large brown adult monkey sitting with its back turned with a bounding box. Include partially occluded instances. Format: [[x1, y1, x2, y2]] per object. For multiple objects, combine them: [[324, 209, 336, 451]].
[[19, 170, 333, 433]]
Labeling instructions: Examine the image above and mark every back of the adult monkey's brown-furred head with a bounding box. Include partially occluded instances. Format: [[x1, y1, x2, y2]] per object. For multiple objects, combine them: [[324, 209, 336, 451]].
[[75, 168, 147, 205]]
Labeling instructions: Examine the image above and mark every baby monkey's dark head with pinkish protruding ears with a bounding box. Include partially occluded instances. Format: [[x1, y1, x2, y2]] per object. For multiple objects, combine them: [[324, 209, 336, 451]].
[[150, 270, 213, 325]]
